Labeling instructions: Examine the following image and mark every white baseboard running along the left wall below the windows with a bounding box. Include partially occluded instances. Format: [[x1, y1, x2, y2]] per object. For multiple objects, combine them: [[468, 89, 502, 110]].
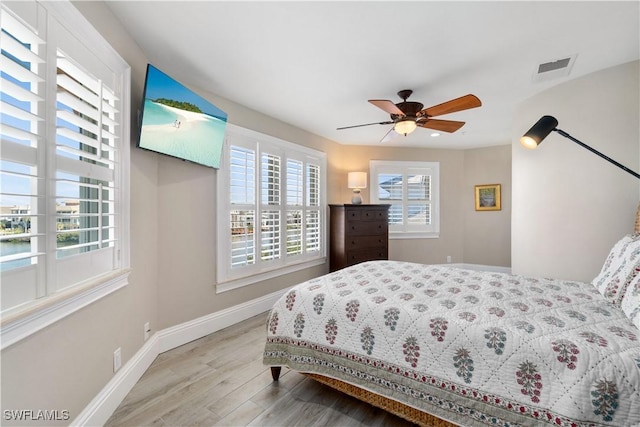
[[70, 289, 288, 426]]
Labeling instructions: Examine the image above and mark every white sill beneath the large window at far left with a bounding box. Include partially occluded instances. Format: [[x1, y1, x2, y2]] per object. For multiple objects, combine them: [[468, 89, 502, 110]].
[[0, 269, 131, 350]]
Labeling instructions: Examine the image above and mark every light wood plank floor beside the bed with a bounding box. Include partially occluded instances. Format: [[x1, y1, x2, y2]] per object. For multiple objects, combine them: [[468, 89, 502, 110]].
[[106, 313, 416, 427]]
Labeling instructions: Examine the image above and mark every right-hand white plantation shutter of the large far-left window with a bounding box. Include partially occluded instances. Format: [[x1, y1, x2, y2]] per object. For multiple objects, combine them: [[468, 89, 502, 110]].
[[56, 52, 118, 254]]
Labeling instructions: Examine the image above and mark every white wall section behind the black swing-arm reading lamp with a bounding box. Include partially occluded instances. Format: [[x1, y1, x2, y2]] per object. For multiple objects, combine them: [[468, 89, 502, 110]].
[[512, 61, 640, 281]]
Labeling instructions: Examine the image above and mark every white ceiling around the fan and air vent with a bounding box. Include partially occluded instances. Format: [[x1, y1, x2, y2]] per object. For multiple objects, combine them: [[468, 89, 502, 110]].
[[107, 0, 640, 148]]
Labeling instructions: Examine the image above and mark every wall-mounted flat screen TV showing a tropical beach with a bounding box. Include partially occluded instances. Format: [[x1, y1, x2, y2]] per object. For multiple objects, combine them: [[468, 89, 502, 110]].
[[138, 64, 227, 168]]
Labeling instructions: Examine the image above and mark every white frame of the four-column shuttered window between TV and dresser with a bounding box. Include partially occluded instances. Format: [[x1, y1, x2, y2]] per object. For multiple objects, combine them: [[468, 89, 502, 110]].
[[216, 123, 327, 293]]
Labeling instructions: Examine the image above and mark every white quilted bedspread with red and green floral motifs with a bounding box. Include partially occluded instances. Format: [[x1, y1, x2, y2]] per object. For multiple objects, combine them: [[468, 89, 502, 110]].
[[264, 261, 640, 426]]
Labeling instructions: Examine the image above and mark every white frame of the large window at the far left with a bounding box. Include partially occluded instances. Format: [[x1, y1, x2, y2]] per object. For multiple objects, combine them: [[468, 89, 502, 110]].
[[0, 1, 131, 349]]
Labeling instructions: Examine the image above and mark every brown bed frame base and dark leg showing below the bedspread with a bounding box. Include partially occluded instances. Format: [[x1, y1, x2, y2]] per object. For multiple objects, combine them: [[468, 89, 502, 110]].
[[271, 366, 456, 427]]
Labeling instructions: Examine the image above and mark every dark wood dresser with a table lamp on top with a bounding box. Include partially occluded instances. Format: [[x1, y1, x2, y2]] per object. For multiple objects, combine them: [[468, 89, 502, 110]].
[[329, 205, 390, 271]]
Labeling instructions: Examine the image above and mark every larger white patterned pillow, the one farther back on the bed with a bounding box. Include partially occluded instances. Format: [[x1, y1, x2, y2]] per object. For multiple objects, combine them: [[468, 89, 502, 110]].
[[591, 234, 640, 307]]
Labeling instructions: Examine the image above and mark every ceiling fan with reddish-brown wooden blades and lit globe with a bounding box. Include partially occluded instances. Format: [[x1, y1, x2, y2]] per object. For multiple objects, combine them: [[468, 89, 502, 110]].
[[337, 89, 482, 142]]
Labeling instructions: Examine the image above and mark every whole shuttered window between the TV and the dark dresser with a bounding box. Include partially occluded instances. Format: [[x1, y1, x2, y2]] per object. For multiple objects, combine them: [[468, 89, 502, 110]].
[[217, 125, 326, 292]]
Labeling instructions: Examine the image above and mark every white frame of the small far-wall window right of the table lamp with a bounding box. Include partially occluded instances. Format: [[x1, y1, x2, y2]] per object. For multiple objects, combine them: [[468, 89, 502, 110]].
[[369, 160, 440, 239]]
